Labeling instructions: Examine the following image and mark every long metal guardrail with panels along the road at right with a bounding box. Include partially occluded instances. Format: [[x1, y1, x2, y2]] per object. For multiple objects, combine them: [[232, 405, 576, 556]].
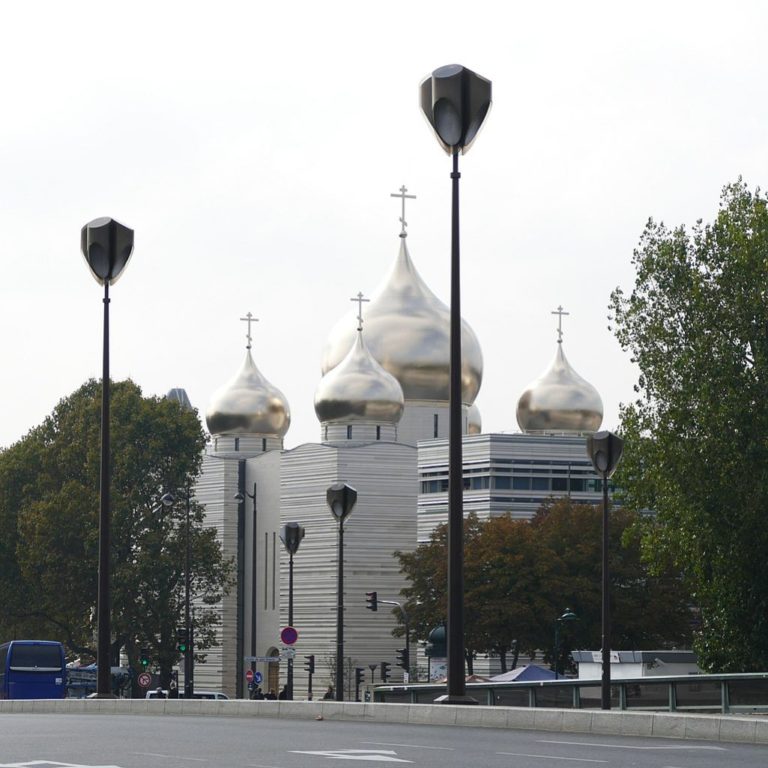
[[373, 672, 768, 714]]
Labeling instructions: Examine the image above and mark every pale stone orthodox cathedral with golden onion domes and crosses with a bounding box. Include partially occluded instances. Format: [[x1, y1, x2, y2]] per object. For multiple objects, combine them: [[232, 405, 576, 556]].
[[180, 187, 603, 700]]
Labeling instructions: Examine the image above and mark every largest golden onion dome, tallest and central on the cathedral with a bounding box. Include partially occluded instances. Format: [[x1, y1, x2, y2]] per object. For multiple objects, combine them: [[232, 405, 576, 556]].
[[322, 233, 483, 405]]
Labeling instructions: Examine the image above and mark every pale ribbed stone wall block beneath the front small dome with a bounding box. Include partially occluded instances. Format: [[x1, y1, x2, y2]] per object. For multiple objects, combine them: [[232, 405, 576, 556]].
[[281, 443, 416, 698]]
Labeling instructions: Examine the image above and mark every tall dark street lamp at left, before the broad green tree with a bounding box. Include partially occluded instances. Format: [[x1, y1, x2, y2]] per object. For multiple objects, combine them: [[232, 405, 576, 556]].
[[80, 217, 133, 698]]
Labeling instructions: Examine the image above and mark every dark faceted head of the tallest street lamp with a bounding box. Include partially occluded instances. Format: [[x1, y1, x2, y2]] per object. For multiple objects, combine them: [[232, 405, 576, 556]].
[[419, 64, 491, 155]]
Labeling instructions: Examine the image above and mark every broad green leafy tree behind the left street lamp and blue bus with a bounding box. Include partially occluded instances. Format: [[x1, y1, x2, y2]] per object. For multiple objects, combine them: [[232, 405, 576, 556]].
[[0, 381, 232, 685]]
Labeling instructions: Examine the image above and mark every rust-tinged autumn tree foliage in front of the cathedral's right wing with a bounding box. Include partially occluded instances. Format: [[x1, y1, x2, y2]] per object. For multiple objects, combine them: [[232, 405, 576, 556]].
[[397, 499, 690, 673]]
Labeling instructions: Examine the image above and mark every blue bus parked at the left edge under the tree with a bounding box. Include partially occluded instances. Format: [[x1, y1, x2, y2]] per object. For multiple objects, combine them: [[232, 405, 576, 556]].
[[0, 640, 67, 699]]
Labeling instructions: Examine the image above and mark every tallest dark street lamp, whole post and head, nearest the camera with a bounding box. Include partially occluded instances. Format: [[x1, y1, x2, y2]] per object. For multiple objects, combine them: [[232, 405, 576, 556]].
[[420, 64, 491, 704]]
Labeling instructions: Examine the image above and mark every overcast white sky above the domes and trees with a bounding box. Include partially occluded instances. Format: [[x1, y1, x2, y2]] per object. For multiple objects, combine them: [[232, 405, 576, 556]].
[[0, 0, 768, 447]]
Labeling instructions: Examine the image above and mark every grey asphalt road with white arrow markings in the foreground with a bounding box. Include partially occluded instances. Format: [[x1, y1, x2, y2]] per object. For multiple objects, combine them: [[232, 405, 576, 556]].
[[0, 714, 768, 768]]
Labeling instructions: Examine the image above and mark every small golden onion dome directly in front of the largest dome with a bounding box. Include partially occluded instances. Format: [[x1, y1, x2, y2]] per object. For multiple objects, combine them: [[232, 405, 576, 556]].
[[315, 330, 405, 424]]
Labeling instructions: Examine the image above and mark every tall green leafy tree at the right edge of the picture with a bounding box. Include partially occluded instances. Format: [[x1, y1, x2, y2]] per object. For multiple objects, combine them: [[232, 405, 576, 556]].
[[611, 179, 768, 672]]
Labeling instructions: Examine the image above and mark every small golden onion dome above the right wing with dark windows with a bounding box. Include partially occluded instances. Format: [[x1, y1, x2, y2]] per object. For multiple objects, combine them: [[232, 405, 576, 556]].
[[517, 341, 603, 432]]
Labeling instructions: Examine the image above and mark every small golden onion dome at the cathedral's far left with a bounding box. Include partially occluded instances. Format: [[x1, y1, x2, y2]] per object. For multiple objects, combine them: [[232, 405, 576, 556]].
[[205, 349, 291, 437]]
